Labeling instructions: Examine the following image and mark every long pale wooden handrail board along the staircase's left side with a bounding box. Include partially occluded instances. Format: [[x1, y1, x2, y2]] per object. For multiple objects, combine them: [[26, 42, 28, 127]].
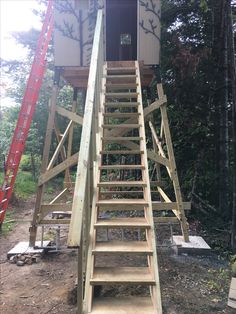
[[67, 10, 104, 248]]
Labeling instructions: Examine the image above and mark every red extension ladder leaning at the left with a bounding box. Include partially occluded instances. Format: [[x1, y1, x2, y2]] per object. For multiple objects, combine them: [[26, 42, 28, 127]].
[[0, 0, 54, 226]]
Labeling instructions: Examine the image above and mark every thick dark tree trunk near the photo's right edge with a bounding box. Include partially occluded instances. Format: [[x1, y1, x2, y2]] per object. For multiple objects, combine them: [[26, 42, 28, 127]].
[[213, 0, 229, 216]]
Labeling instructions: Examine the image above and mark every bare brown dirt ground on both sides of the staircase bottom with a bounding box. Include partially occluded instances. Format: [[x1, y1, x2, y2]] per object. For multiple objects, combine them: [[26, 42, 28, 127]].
[[0, 201, 236, 314]]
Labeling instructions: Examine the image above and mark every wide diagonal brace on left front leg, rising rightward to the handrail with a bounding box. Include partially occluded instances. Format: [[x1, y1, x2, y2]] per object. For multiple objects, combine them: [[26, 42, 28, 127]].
[[38, 153, 79, 186]]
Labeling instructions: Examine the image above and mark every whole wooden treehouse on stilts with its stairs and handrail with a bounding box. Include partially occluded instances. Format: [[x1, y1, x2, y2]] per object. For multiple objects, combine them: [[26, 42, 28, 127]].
[[24, 0, 194, 314]]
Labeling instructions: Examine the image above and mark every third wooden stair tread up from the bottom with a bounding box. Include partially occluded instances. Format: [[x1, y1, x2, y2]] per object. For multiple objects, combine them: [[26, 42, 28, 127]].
[[92, 241, 153, 255]]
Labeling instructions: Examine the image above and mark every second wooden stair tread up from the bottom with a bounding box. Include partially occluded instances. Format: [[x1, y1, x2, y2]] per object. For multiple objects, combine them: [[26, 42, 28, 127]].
[[90, 267, 155, 285]]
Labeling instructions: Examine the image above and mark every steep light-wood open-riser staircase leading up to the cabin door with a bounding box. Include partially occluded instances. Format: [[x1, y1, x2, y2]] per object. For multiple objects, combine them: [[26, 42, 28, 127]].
[[83, 62, 162, 314]]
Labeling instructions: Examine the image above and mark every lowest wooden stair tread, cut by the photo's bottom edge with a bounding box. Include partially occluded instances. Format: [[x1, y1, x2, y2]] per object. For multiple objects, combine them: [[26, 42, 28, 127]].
[[91, 297, 156, 314]]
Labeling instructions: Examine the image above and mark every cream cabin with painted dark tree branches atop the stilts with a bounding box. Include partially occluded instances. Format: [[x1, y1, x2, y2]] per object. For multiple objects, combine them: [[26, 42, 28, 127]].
[[54, 0, 160, 89]]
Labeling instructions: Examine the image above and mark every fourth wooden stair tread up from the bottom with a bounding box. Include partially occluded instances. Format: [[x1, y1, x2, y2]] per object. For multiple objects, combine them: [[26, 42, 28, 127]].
[[94, 217, 150, 228]]
